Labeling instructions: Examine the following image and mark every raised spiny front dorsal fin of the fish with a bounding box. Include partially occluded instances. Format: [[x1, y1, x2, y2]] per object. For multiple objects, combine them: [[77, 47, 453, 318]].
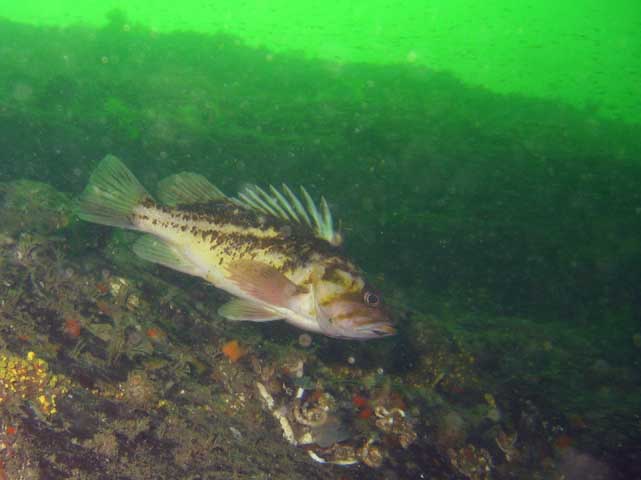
[[234, 184, 343, 246]]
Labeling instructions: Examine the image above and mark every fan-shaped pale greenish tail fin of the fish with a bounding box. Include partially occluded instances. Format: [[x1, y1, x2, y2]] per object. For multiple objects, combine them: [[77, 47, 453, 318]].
[[77, 155, 151, 229]]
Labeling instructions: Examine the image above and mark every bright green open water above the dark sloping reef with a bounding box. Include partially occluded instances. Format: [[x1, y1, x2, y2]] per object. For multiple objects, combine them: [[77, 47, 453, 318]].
[[2, 0, 641, 123]]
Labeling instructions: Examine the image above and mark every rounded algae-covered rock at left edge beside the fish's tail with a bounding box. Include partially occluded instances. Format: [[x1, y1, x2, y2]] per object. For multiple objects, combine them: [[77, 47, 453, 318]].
[[0, 180, 72, 235]]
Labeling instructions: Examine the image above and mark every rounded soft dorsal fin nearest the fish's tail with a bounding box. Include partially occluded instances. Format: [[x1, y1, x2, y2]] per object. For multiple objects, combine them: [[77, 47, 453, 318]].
[[158, 172, 225, 206]]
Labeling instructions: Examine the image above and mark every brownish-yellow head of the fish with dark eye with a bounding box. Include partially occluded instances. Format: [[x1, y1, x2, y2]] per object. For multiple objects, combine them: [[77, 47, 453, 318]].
[[313, 268, 396, 340]]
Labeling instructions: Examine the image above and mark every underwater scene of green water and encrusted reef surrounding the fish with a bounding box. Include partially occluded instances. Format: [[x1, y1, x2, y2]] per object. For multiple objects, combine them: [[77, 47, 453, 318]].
[[0, 0, 641, 480]]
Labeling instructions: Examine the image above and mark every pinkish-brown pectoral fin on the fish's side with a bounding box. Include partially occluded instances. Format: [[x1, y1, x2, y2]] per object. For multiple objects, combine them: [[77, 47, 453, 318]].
[[227, 260, 298, 307]]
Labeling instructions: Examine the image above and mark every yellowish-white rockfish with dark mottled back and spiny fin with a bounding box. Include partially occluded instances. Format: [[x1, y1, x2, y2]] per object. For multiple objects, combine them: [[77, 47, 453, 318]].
[[76, 155, 396, 340]]
